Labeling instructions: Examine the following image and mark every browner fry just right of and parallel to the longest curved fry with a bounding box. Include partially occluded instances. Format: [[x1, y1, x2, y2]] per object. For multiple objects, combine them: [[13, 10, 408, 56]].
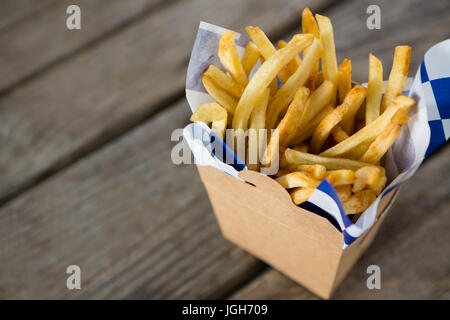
[[266, 39, 322, 130]]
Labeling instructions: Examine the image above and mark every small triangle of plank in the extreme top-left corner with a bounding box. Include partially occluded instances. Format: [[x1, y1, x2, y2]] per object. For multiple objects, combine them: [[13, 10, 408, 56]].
[[0, 0, 55, 29]]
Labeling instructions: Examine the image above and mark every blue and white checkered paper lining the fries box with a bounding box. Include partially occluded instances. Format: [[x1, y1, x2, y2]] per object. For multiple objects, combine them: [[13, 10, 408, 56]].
[[183, 22, 450, 249]]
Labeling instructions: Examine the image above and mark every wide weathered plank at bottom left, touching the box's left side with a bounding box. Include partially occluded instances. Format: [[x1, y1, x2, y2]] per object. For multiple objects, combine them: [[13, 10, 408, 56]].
[[0, 101, 263, 299]]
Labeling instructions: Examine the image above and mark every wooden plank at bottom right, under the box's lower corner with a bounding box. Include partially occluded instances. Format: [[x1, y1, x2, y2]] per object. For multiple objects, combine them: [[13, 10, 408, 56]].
[[231, 147, 450, 299]]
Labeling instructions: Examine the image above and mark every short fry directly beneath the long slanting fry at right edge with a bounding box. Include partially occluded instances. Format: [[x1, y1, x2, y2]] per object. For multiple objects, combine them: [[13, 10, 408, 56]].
[[361, 123, 402, 163]]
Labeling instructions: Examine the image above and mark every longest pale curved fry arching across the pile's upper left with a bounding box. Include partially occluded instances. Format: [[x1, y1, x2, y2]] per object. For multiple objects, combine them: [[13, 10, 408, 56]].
[[232, 34, 313, 130]]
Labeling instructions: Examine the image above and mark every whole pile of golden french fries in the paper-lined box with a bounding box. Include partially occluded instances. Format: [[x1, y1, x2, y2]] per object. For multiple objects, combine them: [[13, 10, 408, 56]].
[[191, 8, 415, 221]]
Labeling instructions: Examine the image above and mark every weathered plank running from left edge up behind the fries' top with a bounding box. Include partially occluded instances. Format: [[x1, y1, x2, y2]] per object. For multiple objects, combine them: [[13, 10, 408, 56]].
[[0, 0, 334, 200]]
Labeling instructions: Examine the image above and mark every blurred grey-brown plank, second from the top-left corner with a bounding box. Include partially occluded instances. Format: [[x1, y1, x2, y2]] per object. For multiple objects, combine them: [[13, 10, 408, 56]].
[[0, 0, 170, 92]]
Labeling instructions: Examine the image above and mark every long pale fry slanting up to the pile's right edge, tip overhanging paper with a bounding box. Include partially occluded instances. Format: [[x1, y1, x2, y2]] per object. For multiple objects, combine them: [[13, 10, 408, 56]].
[[320, 96, 416, 157]]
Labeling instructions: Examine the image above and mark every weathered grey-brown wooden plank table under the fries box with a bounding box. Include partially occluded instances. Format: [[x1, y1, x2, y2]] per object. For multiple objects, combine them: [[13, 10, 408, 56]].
[[0, 0, 450, 299]]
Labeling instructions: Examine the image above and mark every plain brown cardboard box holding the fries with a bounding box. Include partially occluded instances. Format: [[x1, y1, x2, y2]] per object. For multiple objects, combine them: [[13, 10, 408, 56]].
[[198, 166, 398, 299]]
